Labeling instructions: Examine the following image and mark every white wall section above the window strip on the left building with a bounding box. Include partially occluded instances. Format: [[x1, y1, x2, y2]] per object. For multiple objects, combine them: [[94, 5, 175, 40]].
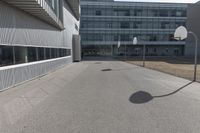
[[0, 1, 79, 48]]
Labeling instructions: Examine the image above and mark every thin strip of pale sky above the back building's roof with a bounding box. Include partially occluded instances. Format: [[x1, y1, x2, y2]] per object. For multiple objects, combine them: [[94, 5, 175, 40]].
[[115, 0, 199, 3]]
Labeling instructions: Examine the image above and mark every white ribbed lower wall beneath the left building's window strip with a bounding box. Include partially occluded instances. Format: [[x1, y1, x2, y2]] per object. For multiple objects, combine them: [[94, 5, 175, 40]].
[[0, 58, 72, 90]]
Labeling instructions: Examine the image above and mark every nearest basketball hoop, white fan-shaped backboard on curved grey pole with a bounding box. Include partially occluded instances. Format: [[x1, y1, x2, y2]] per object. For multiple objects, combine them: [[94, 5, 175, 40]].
[[174, 26, 198, 81]]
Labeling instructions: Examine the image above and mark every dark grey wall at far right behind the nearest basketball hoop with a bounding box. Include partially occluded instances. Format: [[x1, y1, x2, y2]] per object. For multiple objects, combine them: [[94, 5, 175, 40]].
[[185, 4, 200, 56]]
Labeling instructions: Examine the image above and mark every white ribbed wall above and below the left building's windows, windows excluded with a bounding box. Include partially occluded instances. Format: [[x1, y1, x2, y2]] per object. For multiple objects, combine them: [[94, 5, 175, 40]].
[[0, 1, 79, 90]]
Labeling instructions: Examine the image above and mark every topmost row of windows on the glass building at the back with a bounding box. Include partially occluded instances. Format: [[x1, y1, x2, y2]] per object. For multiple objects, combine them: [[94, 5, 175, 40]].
[[82, 7, 187, 17]]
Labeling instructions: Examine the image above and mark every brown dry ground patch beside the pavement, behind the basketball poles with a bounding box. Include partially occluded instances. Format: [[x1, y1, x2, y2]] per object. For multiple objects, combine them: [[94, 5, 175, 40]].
[[117, 57, 200, 82]]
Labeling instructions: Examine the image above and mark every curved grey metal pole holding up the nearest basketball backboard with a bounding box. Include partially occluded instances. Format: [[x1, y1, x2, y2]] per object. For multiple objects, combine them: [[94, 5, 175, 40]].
[[189, 31, 198, 81]]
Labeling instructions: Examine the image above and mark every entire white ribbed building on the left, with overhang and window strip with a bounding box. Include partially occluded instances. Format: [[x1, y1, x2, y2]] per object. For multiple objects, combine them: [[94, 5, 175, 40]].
[[0, 0, 80, 90]]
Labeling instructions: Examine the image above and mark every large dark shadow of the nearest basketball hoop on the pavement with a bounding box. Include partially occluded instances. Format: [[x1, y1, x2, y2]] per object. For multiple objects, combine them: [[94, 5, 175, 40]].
[[129, 81, 193, 104]]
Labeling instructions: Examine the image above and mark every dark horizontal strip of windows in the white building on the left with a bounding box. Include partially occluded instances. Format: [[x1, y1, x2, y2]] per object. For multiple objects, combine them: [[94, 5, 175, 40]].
[[0, 45, 71, 66]]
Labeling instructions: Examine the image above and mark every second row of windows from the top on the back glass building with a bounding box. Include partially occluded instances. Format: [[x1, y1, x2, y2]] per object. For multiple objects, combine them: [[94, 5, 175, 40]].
[[81, 21, 186, 29]]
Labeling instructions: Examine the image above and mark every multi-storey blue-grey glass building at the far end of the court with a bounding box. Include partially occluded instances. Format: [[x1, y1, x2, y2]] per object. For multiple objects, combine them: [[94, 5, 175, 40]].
[[80, 0, 187, 56]]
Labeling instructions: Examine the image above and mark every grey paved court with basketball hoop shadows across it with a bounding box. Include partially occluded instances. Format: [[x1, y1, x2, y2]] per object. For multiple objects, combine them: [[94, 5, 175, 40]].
[[0, 61, 200, 133]]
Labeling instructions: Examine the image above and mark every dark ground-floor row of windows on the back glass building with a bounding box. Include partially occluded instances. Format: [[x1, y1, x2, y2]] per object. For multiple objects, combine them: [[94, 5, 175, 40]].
[[82, 45, 184, 56]]
